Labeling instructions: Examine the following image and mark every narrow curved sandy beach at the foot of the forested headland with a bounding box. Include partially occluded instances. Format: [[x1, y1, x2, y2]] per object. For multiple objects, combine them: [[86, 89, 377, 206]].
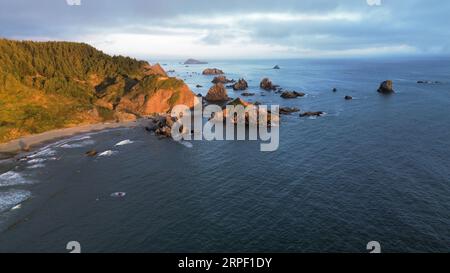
[[0, 119, 142, 159]]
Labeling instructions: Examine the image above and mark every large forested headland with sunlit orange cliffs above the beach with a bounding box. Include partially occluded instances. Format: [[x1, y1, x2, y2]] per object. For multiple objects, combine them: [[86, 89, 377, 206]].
[[0, 39, 195, 142]]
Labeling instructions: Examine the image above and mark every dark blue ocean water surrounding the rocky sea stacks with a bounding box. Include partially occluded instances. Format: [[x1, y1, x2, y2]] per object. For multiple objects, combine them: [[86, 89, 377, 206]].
[[0, 59, 450, 253]]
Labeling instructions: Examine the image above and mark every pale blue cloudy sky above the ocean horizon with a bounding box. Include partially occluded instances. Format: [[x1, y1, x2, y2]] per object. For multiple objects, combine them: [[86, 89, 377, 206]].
[[0, 0, 450, 59]]
